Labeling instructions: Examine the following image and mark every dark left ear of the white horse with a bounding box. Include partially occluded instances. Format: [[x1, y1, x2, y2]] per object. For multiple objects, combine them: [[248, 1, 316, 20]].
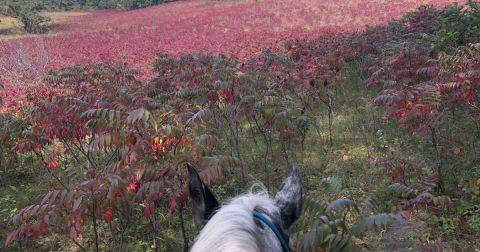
[[187, 164, 220, 224]]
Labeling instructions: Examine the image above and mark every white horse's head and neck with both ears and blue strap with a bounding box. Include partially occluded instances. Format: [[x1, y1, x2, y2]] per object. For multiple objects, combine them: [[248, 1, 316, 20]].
[[187, 164, 302, 252]]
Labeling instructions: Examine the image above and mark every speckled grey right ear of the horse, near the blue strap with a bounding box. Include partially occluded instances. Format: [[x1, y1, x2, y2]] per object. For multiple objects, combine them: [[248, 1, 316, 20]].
[[275, 165, 302, 229]]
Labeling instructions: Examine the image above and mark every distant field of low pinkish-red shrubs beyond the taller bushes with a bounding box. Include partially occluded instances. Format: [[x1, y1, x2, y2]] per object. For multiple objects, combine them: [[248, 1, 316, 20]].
[[0, 0, 454, 108]]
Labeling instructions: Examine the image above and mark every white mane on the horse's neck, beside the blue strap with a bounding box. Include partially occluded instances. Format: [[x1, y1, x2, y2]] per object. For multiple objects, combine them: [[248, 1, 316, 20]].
[[191, 189, 281, 252]]
